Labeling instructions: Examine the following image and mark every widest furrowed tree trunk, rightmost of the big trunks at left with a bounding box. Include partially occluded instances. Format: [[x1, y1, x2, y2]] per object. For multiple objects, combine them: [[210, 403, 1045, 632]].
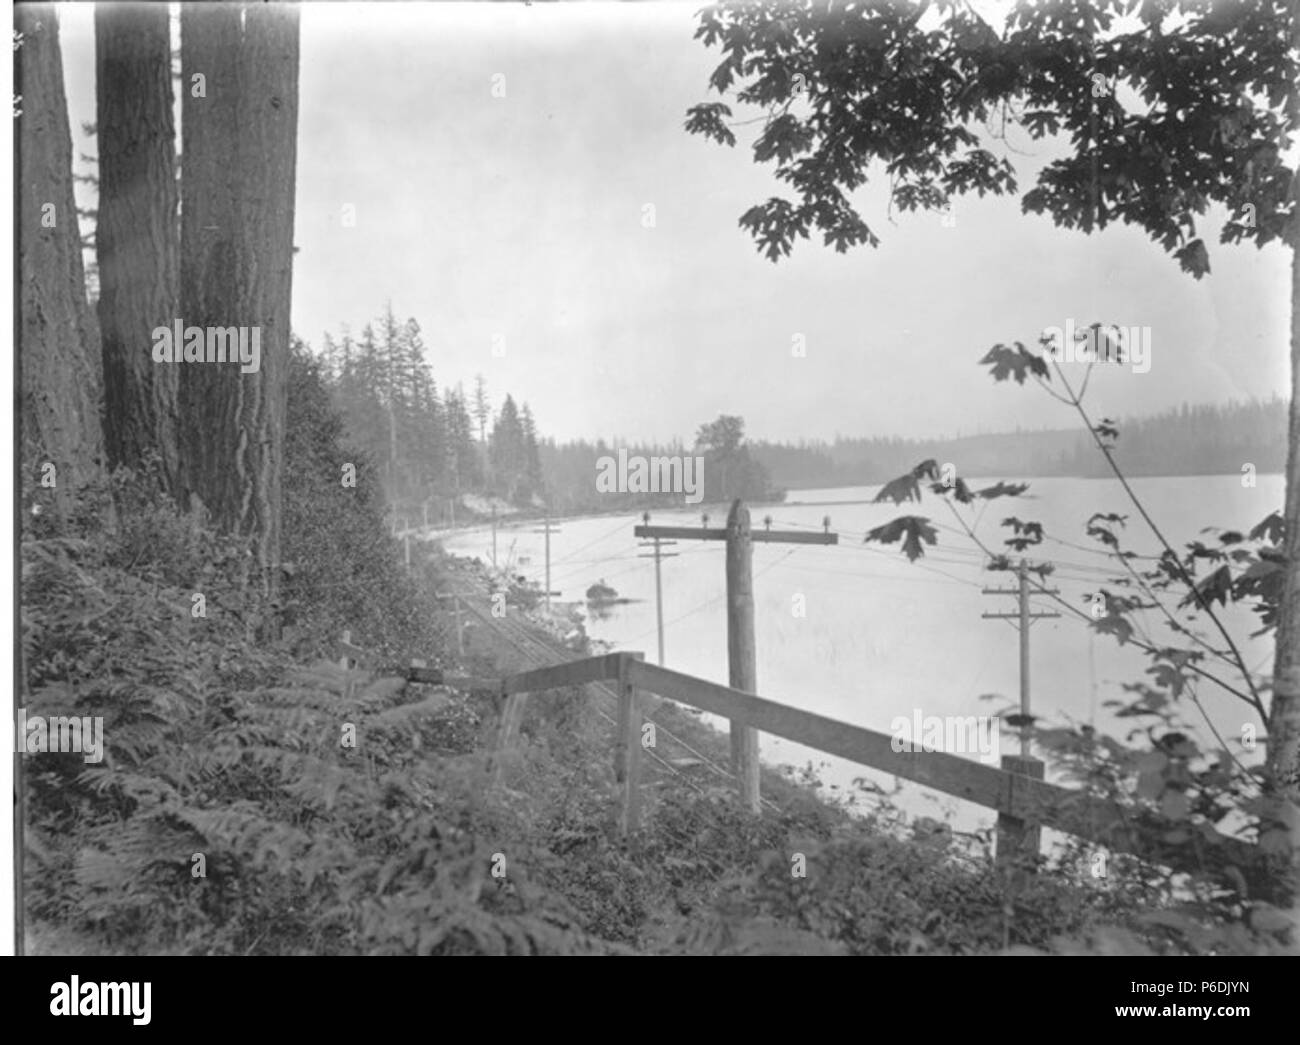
[[176, 4, 298, 631]]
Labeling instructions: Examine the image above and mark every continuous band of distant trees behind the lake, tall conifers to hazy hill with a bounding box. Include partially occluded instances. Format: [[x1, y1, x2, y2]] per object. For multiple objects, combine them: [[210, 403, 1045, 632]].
[[312, 314, 1287, 521]]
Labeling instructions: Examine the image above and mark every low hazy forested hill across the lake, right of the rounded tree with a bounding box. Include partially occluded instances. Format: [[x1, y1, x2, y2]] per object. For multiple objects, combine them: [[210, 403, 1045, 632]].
[[750, 398, 1287, 489]]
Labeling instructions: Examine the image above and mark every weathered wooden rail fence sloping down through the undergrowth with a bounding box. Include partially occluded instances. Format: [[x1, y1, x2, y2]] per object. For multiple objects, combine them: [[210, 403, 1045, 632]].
[[494, 652, 1265, 892]]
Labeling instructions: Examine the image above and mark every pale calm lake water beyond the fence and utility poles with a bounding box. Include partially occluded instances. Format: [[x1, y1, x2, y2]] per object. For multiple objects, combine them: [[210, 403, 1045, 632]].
[[443, 476, 1283, 831]]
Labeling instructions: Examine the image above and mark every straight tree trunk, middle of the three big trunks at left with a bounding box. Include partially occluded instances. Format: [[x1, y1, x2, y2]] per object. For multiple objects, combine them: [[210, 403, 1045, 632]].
[[95, 4, 179, 491]]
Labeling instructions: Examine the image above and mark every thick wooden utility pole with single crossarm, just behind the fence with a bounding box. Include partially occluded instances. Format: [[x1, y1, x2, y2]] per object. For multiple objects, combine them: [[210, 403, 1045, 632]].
[[632, 498, 840, 814]]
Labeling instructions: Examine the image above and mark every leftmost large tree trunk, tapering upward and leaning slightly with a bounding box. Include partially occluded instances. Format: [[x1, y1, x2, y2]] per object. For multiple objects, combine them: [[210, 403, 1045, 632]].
[[14, 4, 103, 508]]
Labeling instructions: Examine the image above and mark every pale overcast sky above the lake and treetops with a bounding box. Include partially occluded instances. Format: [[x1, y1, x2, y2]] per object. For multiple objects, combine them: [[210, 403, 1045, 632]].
[[60, 3, 1290, 445]]
